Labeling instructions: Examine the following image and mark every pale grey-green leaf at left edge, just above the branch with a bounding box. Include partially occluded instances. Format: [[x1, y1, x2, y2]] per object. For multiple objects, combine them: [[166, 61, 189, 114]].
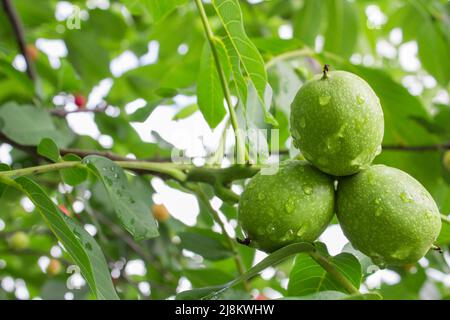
[[0, 102, 73, 147]]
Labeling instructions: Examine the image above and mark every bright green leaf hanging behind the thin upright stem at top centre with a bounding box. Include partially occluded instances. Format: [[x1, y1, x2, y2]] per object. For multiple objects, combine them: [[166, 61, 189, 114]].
[[197, 41, 230, 128]]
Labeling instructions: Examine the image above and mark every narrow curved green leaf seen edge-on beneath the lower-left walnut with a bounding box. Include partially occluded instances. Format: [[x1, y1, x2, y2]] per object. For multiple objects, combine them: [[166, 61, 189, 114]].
[[176, 242, 315, 300]]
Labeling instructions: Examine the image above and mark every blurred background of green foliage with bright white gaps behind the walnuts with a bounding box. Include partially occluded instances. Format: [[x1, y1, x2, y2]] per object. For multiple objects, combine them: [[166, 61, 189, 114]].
[[0, 0, 450, 299]]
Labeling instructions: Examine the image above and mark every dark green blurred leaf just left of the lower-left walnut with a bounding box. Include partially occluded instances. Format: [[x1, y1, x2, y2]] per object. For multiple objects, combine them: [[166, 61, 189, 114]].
[[179, 228, 233, 260]]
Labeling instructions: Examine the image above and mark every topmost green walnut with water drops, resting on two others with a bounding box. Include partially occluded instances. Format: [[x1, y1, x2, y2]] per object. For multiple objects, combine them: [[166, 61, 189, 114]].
[[291, 65, 384, 176]]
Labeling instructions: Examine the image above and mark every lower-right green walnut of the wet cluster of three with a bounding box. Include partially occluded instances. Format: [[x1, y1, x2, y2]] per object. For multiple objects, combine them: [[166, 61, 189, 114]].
[[336, 165, 441, 265]]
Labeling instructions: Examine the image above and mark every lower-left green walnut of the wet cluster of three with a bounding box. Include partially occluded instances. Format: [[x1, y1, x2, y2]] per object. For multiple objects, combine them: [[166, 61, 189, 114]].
[[238, 160, 334, 252]]
